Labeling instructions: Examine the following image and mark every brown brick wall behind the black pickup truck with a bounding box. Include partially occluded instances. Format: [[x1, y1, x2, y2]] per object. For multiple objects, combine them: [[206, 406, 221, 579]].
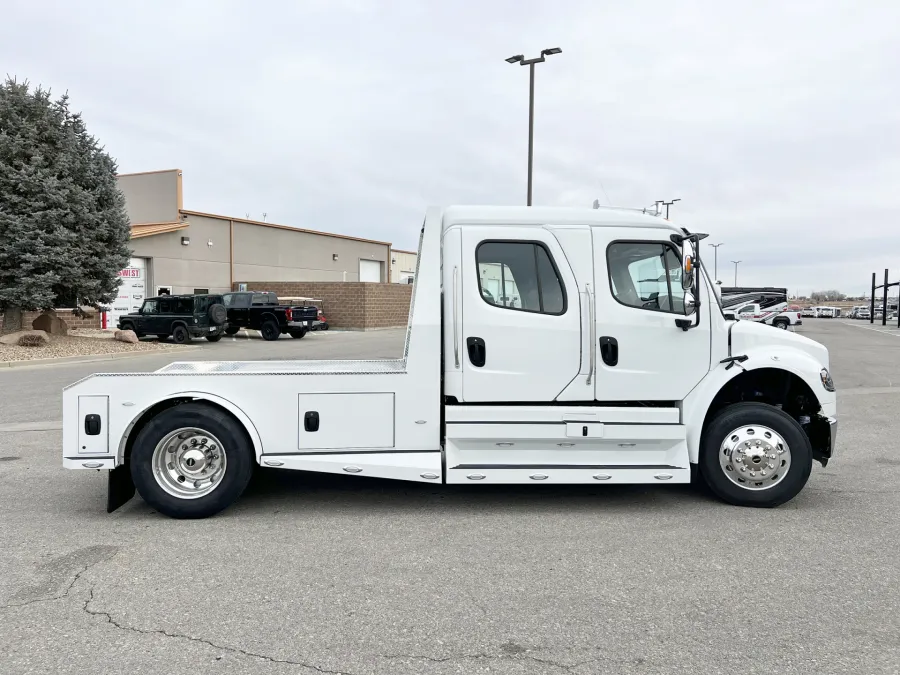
[[234, 281, 413, 330]]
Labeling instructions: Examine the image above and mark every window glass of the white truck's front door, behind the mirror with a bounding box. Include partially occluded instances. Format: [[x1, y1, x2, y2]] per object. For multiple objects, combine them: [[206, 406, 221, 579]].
[[606, 242, 684, 314]]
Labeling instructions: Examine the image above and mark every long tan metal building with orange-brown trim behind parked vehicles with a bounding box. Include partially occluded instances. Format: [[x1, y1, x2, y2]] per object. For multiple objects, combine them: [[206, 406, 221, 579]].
[[114, 169, 394, 314]]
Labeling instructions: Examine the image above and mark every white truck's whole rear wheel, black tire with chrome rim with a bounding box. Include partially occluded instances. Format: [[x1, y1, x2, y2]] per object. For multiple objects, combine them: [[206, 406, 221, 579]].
[[131, 403, 254, 518]]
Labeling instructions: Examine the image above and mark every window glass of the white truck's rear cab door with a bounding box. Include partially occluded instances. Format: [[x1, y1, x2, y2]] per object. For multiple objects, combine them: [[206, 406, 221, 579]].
[[475, 241, 566, 315]]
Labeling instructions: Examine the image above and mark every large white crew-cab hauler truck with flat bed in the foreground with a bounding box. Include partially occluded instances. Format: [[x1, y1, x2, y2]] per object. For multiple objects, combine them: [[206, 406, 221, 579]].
[[63, 206, 836, 518]]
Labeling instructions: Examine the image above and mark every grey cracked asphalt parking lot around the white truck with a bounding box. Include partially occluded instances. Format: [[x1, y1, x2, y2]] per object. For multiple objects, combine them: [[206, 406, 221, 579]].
[[0, 319, 900, 675]]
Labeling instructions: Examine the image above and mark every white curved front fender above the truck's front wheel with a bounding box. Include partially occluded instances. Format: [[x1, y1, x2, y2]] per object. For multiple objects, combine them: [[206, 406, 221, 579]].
[[682, 346, 834, 464]]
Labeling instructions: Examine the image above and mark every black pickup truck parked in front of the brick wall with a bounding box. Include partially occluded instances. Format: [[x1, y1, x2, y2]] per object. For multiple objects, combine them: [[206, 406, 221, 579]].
[[222, 291, 319, 340]]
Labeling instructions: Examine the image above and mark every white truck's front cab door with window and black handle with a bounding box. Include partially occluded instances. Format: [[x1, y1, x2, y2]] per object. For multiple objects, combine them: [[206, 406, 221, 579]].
[[593, 228, 715, 402]]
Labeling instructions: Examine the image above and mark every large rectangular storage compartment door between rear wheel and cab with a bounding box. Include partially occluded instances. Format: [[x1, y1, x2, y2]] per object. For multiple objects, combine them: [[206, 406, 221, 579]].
[[297, 393, 394, 451]]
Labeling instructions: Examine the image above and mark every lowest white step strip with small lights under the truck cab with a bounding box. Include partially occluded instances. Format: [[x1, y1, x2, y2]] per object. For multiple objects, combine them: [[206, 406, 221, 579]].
[[447, 464, 691, 484]]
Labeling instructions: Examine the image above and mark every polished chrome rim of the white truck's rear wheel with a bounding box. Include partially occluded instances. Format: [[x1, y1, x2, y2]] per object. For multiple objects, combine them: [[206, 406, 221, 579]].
[[151, 427, 226, 499]]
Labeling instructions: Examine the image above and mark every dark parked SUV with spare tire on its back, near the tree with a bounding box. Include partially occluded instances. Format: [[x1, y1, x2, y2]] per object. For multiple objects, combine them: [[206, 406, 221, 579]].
[[118, 295, 228, 344]]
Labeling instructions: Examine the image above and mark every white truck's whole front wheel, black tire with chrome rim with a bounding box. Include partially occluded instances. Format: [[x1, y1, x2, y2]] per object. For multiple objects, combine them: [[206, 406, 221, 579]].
[[700, 403, 813, 507]]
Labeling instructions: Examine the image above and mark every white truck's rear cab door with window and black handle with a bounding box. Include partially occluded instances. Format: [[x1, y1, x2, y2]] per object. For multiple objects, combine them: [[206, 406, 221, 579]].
[[460, 225, 586, 403]]
